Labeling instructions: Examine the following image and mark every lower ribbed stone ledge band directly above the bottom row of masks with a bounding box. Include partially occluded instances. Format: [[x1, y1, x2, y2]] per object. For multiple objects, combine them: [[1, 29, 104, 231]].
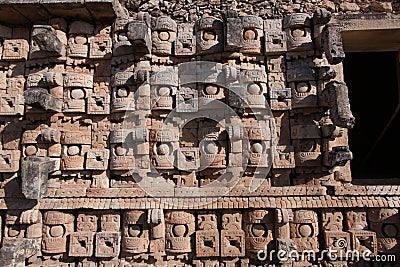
[[0, 196, 400, 210]]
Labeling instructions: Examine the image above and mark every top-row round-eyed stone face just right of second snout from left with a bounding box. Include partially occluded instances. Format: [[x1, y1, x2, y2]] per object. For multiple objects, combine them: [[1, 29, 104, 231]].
[[151, 17, 177, 55]]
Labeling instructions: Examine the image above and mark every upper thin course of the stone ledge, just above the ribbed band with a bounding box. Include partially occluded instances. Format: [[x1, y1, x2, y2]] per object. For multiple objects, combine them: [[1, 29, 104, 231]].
[[4, 185, 400, 200]]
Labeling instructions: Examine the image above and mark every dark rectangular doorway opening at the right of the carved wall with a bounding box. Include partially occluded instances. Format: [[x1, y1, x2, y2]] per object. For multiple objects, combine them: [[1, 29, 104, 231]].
[[343, 52, 400, 180]]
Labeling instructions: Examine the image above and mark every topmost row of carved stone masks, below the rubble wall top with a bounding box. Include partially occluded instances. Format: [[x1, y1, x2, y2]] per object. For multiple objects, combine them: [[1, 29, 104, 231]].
[[0, 13, 342, 61]]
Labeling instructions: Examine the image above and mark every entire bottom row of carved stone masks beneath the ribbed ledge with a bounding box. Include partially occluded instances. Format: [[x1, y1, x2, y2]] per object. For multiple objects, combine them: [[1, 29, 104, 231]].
[[4, 208, 399, 259]]
